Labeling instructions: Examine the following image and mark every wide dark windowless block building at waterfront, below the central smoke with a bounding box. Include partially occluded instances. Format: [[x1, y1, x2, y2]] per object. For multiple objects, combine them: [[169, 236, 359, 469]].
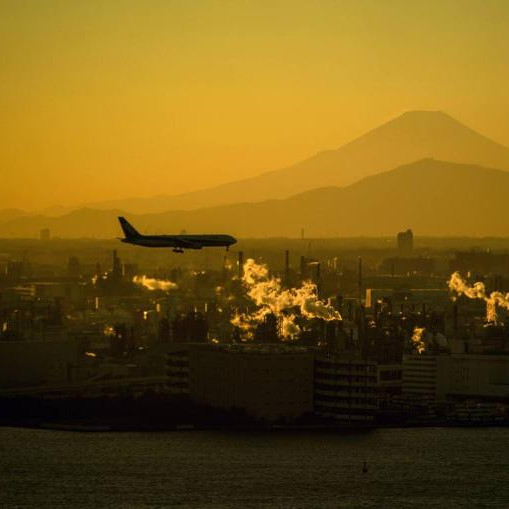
[[167, 344, 313, 422]]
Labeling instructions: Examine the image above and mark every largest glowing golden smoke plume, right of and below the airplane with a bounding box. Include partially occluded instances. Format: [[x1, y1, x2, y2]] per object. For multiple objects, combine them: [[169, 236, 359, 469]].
[[231, 258, 341, 340]]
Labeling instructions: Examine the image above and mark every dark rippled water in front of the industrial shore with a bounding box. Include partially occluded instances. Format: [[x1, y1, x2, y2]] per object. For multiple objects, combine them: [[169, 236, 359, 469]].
[[0, 428, 509, 509]]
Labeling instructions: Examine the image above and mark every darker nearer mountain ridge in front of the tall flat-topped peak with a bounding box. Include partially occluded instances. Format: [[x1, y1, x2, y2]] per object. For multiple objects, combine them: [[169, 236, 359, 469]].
[[0, 159, 509, 238]]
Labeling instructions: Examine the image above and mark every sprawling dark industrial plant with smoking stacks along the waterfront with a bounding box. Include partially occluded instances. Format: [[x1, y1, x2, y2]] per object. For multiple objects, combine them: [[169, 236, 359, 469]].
[[0, 230, 509, 428]]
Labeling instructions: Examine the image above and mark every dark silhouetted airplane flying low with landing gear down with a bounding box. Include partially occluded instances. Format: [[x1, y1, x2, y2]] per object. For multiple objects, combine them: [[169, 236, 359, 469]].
[[118, 217, 237, 253]]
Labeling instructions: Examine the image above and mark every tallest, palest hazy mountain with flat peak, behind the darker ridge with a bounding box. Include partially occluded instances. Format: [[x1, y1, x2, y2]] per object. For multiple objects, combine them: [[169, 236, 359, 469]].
[[77, 111, 509, 213]]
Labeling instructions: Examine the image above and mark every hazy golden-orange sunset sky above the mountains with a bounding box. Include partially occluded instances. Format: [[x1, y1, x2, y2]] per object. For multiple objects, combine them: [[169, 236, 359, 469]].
[[0, 0, 509, 209]]
